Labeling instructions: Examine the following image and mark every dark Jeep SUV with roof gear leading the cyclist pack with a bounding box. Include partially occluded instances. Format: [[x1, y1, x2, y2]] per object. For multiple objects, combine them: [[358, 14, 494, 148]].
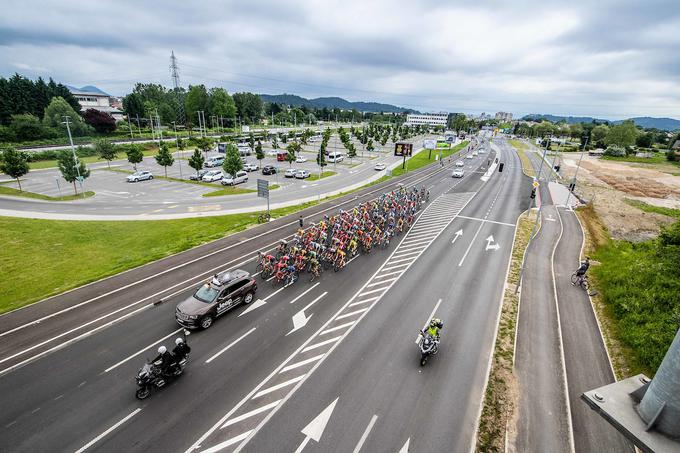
[[175, 269, 257, 329]]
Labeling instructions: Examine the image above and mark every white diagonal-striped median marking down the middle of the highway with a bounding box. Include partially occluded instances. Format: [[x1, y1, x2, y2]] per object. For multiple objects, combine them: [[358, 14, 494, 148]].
[[191, 192, 475, 451]]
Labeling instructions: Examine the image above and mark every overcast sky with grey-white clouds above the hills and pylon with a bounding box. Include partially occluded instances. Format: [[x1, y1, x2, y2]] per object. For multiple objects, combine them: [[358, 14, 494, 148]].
[[0, 0, 680, 119]]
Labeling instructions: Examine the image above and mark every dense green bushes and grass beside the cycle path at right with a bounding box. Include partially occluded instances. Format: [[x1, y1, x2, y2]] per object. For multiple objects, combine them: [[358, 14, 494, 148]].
[[578, 200, 680, 376]]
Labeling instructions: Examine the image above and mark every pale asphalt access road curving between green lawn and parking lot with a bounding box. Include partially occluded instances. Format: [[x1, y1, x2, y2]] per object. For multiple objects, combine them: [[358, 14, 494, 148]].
[[0, 137, 436, 220]]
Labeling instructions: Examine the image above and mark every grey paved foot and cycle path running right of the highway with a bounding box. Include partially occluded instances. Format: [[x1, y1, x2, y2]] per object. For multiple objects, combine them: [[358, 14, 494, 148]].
[[510, 141, 633, 453]]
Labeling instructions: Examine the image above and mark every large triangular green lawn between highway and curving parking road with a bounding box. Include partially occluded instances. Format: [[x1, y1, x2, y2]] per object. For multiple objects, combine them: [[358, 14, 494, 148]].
[[0, 202, 316, 313]]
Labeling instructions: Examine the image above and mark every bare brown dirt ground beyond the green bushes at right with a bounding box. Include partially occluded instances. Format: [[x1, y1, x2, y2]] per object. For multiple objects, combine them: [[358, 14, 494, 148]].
[[561, 153, 680, 241]]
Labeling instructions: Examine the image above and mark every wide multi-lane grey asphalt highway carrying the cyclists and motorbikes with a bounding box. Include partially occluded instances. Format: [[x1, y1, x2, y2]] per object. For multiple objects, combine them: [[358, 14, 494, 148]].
[[0, 137, 529, 452]]
